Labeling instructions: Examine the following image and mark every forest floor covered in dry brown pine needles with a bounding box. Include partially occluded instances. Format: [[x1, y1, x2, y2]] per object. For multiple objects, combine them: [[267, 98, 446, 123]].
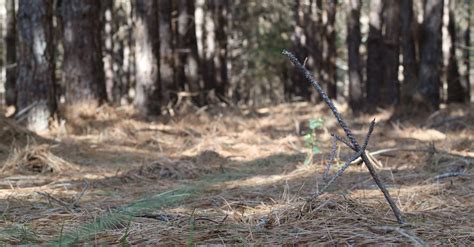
[[0, 103, 474, 246]]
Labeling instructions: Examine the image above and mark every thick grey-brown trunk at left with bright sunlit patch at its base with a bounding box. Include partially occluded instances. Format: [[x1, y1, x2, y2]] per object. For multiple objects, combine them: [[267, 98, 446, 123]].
[[16, 0, 57, 131]]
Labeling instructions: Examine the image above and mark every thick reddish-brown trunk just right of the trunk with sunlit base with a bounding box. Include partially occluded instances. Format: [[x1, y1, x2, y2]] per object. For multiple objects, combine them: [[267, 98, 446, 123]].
[[61, 0, 107, 105]]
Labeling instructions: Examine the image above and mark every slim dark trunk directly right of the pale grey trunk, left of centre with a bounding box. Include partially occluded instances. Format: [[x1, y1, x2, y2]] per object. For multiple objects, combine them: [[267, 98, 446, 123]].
[[158, 0, 175, 106]]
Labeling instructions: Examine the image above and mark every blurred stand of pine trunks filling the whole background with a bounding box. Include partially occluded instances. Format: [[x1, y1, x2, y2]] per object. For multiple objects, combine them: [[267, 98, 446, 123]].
[[0, 0, 473, 130]]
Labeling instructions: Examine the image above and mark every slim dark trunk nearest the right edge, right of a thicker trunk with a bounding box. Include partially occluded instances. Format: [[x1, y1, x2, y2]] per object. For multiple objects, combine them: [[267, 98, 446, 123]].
[[447, 0, 468, 103]]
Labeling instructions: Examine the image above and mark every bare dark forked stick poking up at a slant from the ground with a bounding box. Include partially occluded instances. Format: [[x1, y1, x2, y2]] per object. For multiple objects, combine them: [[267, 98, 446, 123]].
[[283, 50, 404, 224]]
